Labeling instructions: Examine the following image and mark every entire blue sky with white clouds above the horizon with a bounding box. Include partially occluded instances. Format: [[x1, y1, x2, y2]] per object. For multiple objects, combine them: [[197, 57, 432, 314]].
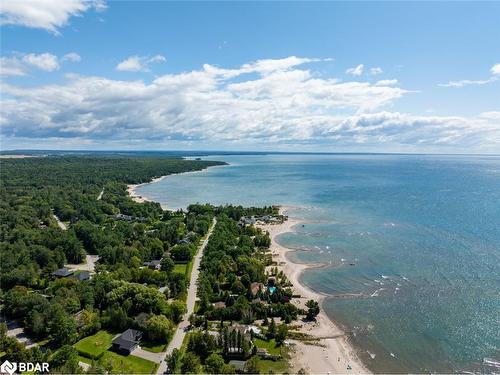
[[0, 0, 500, 154]]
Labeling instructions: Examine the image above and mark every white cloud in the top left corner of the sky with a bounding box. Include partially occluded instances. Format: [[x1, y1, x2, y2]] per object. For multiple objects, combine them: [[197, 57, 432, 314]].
[[0, 0, 106, 34]]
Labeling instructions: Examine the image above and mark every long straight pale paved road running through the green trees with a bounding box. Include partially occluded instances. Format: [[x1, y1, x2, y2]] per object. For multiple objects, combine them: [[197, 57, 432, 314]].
[[157, 218, 217, 374]]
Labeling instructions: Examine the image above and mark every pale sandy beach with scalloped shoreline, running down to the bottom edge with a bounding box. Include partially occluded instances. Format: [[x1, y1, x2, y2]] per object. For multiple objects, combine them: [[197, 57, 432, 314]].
[[257, 207, 370, 374]]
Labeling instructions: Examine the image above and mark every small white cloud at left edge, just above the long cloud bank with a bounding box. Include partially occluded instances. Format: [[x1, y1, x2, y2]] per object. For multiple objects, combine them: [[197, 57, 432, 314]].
[[0, 52, 81, 76]]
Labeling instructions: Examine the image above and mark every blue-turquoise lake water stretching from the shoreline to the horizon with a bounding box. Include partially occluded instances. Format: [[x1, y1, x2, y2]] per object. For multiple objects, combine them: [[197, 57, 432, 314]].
[[139, 155, 500, 372]]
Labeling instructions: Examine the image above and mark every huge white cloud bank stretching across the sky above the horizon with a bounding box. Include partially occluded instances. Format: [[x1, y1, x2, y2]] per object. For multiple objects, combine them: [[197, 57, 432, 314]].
[[1, 57, 500, 148]]
